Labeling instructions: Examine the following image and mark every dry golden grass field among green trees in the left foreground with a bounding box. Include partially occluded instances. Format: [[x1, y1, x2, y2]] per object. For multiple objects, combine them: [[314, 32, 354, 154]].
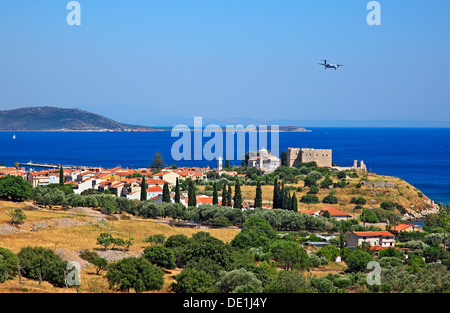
[[0, 201, 239, 293]]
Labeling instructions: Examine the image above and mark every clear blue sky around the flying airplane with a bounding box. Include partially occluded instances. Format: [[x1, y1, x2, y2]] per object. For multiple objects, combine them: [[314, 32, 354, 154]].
[[0, 0, 450, 126]]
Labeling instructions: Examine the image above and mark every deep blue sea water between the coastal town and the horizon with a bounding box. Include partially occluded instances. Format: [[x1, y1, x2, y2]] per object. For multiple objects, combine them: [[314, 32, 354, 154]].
[[0, 128, 450, 203]]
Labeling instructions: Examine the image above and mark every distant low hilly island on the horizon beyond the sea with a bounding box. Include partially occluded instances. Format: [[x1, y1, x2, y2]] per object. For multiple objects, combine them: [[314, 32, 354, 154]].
[[0, 106, 311, 132]]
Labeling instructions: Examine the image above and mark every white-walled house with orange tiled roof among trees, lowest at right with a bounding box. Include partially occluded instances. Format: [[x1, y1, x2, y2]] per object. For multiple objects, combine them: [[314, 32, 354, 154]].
[[347, 231, 395, 249]]
